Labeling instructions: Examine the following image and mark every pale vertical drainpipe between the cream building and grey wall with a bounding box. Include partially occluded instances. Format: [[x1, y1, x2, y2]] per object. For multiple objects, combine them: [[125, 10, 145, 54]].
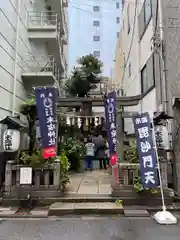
[[158, 0, 168, 113]]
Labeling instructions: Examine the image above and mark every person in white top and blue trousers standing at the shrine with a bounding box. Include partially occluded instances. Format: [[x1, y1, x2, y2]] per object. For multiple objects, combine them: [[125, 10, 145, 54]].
[[85, 137, 95, 171]]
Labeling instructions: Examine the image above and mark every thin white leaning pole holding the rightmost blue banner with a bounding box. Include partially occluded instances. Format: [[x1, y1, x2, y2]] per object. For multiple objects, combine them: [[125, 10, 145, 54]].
[[152, 119, 166, 211]]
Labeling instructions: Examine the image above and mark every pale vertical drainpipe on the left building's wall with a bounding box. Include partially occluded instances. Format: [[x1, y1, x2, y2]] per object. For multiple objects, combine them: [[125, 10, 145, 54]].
[[12, 0, 21, 116]]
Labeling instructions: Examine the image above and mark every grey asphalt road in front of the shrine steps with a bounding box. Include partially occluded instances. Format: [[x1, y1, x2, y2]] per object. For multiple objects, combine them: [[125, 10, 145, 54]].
[[0, 217, 180, 240]]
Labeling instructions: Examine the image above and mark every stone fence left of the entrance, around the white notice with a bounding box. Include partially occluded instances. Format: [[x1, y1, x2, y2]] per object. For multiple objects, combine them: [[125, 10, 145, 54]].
[[4, 161, 61, 198]]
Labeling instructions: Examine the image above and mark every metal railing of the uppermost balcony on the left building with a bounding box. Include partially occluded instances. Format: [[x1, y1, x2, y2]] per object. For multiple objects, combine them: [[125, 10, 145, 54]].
[[27, 11, 58, 28]]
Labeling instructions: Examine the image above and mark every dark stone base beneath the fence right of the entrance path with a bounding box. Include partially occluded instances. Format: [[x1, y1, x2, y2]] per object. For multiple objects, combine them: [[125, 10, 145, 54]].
[[111, 185, 173, 206]]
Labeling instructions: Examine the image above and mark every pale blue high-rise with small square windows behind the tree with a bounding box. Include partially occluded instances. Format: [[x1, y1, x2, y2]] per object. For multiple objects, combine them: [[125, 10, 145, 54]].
[[68, 0, 121, 77]]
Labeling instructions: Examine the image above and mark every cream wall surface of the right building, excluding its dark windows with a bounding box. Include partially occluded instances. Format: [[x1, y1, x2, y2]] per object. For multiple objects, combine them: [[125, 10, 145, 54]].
[[115, 1, 156, 134]]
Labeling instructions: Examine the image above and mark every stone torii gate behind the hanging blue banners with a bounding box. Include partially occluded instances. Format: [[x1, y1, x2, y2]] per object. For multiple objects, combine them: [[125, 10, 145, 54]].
[[57, 94, 143, 161]]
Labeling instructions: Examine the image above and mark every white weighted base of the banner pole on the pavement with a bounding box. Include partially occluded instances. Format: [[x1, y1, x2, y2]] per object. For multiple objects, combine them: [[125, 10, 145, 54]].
[[154, 210, 177, 225]]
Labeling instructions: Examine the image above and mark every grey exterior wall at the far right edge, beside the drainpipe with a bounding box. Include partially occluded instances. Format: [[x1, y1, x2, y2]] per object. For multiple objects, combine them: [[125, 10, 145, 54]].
[[162, 0, 180, 192]]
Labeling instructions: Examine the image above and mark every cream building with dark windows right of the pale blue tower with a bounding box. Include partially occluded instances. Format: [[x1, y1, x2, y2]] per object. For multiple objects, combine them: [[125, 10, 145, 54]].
[[115, 0, 157, 134]]
